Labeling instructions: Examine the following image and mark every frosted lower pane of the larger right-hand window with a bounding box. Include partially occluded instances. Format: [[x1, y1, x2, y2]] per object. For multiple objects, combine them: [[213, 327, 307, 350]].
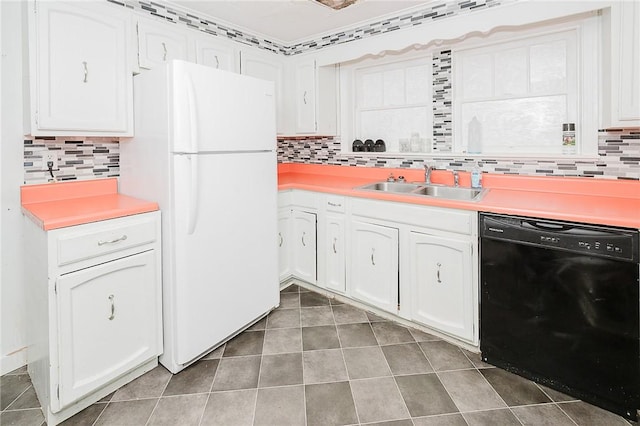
[[456, 95, 567, 154]]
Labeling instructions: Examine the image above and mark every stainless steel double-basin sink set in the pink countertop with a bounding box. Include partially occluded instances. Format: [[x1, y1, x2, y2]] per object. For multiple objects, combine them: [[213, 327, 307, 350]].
[[356, 182, 487, 201]]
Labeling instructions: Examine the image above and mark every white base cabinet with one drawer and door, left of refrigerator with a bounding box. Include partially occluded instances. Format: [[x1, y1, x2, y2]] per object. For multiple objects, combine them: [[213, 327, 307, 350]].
[[25, 212, 162, 425]]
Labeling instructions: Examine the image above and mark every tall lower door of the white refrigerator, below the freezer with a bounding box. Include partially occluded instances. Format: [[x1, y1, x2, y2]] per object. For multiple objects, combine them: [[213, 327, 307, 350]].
[[171, 152, 279, 364]]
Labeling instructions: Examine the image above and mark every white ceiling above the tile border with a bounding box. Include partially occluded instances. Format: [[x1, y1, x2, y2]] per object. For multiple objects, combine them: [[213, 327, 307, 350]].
[[168, 0, 433, 45]]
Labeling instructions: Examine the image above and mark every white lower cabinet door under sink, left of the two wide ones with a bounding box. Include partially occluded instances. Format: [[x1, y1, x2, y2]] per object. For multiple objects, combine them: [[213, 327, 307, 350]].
[[349, 221, 398, 313]]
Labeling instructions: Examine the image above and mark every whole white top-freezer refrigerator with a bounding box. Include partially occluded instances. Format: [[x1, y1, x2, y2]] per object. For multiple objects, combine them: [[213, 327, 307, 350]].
[[120, 60, 279, 373]]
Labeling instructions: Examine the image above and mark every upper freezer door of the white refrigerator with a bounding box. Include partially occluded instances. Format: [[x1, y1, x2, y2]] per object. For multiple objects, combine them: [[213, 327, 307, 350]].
[[170, 61, 276, 153]]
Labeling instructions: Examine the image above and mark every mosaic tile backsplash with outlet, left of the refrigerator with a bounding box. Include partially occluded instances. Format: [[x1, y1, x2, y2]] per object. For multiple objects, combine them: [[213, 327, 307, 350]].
[[24, 137, 120, 184]]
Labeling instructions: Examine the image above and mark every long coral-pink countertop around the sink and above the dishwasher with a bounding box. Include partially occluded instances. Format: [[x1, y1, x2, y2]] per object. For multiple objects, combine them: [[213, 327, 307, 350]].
[[278, 164, 640, 229]]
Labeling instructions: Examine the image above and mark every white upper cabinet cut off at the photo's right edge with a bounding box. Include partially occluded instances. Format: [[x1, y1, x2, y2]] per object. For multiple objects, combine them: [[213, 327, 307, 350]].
[[602, 1, 640, 128]]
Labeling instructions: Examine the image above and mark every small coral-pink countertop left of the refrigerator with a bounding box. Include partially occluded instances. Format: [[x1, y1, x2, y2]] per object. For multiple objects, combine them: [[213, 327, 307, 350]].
[[20, 178, 158, 231]]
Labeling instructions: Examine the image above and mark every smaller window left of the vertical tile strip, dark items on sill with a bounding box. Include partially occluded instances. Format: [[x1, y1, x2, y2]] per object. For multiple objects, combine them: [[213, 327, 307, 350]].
[[341, 53, 433, 154]]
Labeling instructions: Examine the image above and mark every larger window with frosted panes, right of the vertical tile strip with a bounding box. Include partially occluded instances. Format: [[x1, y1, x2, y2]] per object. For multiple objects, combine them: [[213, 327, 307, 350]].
[[452, 18, 599, 157]]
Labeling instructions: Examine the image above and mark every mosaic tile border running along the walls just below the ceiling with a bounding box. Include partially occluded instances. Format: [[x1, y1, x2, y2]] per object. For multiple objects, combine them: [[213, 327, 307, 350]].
[[106, 0, 504, 56]]
